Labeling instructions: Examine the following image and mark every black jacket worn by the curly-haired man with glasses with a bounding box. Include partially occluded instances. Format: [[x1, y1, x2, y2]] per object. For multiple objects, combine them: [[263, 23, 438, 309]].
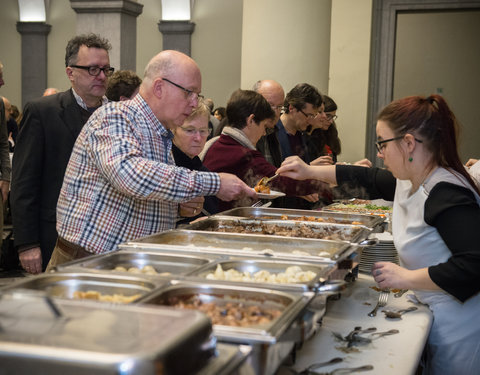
[[10, 89, 89, 268]]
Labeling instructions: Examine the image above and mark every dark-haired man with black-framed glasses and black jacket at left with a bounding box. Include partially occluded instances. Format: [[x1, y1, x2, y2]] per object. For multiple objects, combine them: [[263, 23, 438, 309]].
[[11, 34, 114, 274]]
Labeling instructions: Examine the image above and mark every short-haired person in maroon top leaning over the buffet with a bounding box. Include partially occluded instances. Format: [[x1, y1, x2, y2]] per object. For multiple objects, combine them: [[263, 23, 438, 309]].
[[203, 90, 328, 211]]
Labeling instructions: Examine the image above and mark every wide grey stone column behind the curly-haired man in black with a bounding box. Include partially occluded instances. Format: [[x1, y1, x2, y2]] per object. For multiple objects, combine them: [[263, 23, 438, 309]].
[[70, 0, 143, 71]]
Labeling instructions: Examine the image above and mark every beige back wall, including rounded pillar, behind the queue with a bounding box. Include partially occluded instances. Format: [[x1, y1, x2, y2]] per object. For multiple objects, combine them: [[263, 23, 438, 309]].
[[0, 0, 371, 164]]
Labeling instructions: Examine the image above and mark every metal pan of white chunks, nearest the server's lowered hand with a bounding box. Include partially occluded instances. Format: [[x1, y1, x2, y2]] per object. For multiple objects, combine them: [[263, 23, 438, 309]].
[[186, 257, 334, 291]]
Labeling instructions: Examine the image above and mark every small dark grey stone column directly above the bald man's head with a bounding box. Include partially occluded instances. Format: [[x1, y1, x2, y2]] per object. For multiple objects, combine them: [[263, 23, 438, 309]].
[[158, 21, 195, 56]]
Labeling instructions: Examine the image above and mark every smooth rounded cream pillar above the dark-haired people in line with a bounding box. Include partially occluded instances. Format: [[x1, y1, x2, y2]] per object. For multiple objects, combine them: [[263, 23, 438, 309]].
[[241, 0, 331, 92]]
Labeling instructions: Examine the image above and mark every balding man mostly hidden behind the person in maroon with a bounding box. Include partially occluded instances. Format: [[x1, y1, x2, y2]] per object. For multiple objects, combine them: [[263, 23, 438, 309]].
[[252, 79, 285, 168]]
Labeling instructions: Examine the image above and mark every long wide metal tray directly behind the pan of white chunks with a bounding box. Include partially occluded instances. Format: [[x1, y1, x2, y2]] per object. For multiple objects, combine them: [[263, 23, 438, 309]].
[[123, 230, 358, 263]]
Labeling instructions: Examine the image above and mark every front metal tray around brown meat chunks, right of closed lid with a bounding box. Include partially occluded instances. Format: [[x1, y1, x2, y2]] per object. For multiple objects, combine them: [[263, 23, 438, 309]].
[[138, 280, 314, 375]]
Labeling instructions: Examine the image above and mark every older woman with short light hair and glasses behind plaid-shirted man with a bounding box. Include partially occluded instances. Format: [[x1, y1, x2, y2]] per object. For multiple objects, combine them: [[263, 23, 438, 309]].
[[172, 100, 218, 224]]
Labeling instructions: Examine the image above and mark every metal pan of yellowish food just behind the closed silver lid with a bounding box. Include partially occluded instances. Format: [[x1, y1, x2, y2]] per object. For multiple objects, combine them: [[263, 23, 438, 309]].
[[2, 272, 168, 302]]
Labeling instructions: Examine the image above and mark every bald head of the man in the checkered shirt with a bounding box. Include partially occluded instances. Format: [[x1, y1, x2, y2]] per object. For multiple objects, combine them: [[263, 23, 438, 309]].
[[140, 50, 202, 130]]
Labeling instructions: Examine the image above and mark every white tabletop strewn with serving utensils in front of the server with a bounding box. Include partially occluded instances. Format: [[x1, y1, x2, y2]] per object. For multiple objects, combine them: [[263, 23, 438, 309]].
[[277, 274, 432, 375]]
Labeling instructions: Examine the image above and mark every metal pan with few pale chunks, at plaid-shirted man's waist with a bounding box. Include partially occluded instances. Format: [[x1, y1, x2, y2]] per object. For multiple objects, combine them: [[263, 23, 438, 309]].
[[53, 250, 214, 276]]
